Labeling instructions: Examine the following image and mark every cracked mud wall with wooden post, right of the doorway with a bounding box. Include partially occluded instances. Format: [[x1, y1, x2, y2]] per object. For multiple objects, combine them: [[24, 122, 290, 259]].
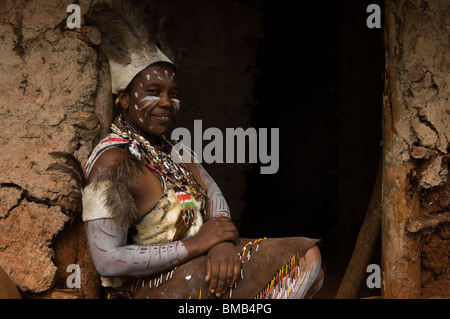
[[383, 0, 450, 298]]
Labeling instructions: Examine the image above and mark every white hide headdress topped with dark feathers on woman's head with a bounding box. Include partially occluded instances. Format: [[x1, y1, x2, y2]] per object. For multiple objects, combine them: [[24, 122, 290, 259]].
[[85, 0, 173, 94]]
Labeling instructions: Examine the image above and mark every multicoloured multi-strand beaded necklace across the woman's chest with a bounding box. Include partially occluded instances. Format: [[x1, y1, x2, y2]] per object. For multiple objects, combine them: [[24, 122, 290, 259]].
[[111, 115, 206, 226]]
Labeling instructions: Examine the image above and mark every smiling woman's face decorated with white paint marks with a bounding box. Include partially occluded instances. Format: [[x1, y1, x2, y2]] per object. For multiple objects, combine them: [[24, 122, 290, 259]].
[[119, 66, 180, 137]]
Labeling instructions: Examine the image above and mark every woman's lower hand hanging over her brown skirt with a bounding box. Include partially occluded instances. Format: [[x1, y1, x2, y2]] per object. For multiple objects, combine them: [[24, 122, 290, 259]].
[[205, 242, 241, 297]]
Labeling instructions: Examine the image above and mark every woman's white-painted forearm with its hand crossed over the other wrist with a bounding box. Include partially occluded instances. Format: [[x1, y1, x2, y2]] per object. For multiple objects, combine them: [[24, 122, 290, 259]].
[[85, 217, 237, 277]]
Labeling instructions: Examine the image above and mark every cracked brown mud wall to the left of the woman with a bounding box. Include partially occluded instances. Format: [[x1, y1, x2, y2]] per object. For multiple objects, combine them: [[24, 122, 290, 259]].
[[0, 1, 102, 295]]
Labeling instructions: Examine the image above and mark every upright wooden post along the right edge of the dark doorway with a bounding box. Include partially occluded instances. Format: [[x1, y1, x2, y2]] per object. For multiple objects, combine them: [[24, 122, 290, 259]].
[[381, 0, 420, 298]]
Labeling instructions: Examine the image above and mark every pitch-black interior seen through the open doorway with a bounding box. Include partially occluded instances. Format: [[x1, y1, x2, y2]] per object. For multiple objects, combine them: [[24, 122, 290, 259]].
[[240, 1, 384, 298]]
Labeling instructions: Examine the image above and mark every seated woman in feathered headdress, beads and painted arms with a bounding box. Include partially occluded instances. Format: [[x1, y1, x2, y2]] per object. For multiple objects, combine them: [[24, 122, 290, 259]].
[[82, 1, 323, 299]]
